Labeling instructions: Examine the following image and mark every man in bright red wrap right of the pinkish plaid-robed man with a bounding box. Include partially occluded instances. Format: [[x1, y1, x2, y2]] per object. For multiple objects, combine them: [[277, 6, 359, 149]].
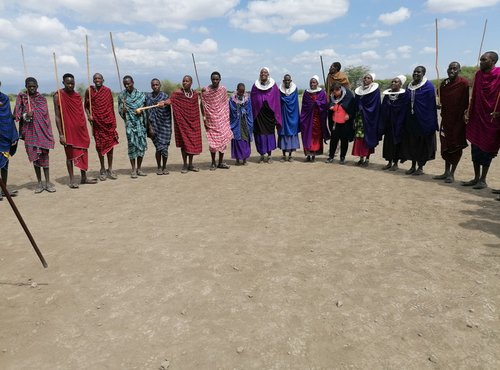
[[54, 73, 97, 189]]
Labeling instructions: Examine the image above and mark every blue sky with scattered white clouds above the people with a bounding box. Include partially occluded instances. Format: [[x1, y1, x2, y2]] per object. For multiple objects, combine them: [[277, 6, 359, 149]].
[[0, 0, 500, 92]]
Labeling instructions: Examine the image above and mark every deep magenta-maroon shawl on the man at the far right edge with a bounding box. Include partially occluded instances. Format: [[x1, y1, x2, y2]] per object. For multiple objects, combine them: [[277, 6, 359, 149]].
[[466, 67, 500, 154]]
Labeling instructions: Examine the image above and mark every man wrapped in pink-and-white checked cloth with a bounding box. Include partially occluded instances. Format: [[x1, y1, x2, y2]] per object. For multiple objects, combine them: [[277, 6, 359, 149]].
[[201, 72, 233, 171]]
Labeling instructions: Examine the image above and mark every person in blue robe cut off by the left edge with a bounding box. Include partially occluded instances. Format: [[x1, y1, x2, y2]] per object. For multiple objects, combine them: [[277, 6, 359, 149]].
[[0, 82, 19, 200]]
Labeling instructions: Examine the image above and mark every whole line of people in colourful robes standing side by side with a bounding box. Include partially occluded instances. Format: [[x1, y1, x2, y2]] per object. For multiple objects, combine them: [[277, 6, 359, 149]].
[[0, 52, 500, 201]]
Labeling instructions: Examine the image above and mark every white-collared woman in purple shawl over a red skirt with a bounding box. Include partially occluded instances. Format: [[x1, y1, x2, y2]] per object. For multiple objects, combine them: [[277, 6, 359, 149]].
[[300, 75, 329, 162]]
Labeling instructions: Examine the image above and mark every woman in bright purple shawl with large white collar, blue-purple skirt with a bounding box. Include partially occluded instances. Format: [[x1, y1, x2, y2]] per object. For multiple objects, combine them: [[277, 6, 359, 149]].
[[250, 67, 281, 163]]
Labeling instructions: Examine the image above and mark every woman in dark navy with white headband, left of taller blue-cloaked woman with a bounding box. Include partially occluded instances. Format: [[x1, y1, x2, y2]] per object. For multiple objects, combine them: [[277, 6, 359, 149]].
[[381, 75, 409, 171]]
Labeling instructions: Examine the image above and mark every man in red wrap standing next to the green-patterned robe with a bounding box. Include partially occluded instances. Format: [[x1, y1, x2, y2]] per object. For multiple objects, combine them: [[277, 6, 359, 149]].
[[85, 73, 118, 181]]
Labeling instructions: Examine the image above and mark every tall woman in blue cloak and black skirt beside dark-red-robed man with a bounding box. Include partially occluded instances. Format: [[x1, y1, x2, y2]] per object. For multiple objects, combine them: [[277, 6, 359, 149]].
[[401, 66, 439, 176]]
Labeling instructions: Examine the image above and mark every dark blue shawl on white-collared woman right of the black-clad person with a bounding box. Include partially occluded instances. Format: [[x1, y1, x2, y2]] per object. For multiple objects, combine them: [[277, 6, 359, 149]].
[[356, 89, 382, 149]]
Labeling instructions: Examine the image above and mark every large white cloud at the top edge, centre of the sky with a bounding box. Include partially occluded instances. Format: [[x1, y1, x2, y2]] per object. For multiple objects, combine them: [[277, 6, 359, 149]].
[[230, 0, 349, 34]]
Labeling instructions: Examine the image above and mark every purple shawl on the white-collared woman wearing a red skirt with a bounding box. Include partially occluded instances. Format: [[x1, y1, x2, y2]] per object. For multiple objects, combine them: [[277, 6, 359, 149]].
[[300, 90, 329, 148]]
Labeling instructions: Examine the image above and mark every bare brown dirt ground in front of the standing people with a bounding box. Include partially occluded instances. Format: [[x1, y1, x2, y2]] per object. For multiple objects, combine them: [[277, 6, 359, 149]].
[[0, 102, 500, 369]]
